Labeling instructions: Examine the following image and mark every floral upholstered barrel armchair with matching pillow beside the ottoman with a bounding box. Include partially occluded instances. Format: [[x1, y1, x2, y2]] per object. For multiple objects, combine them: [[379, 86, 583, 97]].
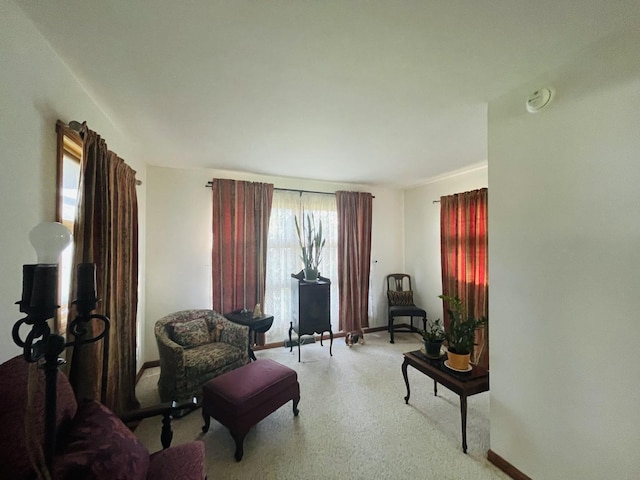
[[155, 309, 249, 402]]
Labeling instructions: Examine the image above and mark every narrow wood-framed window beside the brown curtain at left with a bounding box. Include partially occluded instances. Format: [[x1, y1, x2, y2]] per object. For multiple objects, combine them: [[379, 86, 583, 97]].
[[56, 121, 82, 333]]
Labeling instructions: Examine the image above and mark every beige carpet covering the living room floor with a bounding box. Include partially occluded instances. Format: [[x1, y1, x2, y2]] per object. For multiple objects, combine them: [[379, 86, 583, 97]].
[[136, 332, 509, 480]]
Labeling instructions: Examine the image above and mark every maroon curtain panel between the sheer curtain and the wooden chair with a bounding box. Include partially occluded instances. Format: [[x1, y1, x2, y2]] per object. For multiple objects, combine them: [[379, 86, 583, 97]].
[[336, 192, 373, 333]]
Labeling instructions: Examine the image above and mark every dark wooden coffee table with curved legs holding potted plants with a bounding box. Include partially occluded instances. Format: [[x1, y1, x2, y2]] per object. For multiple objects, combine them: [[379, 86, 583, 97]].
[[402, 350, 489, 453]]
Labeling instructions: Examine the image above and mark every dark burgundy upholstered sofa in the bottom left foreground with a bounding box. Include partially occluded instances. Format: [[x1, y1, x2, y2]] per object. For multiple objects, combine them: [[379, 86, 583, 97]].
[[0, 356, 205, 480]]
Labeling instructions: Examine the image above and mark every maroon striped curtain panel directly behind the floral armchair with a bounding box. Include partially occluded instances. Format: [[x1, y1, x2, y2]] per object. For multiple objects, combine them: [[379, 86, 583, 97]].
[[211, 178, 273, 338]]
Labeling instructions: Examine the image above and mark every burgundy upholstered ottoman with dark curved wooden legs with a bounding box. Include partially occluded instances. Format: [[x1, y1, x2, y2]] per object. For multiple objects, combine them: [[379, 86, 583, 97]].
[[202, 358, 300, 461]]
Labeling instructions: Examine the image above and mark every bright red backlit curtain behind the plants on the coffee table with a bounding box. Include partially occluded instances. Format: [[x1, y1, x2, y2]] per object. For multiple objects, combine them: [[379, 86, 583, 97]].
[[440, 188, 489, 368]]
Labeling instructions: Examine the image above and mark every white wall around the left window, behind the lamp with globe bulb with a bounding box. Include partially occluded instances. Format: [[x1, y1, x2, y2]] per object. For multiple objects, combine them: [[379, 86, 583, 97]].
[[0, 1, 145, 362]]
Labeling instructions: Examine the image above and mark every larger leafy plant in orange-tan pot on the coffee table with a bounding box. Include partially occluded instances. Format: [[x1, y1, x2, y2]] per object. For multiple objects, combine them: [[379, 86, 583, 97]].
[[439, 295, 487, 371]]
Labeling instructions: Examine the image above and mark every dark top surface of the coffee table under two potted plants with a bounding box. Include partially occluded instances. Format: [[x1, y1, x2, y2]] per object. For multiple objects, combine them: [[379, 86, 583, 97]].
[[403, 350, 489, 391]]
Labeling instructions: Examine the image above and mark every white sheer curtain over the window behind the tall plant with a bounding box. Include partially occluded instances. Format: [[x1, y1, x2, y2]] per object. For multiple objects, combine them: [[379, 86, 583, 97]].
[[264, 190, 339, 343]]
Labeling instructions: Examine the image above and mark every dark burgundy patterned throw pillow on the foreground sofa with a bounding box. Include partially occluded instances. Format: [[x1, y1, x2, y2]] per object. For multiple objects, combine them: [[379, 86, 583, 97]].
[[52, 400, 149, 480]]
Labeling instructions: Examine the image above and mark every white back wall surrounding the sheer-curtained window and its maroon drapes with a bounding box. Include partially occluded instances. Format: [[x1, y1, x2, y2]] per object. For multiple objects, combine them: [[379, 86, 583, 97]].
[[144, 166, 402, 361]]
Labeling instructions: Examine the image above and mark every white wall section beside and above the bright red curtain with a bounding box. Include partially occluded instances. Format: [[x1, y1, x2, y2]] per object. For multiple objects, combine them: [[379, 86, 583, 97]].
[[404, 166, 487, 319]]
